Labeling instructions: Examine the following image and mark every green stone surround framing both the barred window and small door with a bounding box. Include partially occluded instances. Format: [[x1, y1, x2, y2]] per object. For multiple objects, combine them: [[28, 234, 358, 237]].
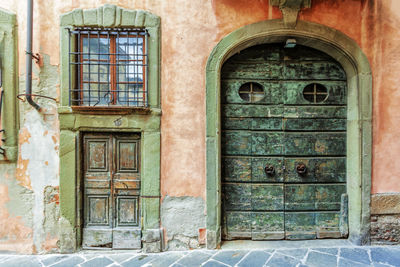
[[58, 4, 161, 253]]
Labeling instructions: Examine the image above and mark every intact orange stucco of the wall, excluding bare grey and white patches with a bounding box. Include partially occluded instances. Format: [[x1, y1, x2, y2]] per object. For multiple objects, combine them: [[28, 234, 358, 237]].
[[0, 0, 400, 201]]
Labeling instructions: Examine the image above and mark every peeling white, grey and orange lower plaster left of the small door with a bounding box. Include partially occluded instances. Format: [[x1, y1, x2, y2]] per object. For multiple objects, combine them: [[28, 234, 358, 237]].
[[0, 51, 59, 253]]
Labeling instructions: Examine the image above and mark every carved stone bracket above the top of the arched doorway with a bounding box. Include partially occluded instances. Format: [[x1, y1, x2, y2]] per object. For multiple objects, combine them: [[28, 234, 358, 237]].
[[269, 0, 311, 28]]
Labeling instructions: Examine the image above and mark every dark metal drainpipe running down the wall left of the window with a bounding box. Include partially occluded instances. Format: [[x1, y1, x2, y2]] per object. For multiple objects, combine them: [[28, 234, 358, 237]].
[[25, 0, 41, 111]]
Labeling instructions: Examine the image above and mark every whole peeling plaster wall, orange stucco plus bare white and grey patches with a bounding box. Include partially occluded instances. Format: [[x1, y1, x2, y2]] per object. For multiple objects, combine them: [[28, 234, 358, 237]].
[[0, 0, 400, 253]]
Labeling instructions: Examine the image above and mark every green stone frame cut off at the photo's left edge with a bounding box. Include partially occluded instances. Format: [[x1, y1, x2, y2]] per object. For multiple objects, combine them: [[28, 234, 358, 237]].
[[0, 9, 19, 162]]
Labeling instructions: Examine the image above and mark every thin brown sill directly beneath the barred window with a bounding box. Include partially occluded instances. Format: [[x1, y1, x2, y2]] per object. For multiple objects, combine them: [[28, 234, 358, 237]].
[[71, 106, 152, 115]]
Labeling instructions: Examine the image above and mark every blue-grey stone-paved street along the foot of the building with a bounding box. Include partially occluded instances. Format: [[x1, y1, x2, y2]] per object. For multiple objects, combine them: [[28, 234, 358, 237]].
[[0, 246, 400, 267]]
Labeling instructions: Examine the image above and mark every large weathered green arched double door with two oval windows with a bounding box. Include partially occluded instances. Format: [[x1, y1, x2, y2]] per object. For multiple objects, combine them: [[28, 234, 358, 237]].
[[221, 44, 348, 240]]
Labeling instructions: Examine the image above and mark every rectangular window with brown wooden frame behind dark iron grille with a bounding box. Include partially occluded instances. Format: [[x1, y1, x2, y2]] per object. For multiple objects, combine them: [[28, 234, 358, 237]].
[[69, 27, 148, 107]]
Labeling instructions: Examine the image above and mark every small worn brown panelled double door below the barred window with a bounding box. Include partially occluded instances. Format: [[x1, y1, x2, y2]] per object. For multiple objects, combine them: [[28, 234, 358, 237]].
[[82, 134, 141, 249]]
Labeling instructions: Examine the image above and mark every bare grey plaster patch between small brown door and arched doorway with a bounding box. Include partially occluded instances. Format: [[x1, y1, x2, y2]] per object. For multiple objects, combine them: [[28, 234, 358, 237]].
[[161, 196, 206, 250]]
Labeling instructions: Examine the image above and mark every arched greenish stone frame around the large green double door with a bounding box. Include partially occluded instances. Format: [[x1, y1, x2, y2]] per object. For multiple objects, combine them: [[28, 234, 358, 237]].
[[206, 19, 372, 249]]
